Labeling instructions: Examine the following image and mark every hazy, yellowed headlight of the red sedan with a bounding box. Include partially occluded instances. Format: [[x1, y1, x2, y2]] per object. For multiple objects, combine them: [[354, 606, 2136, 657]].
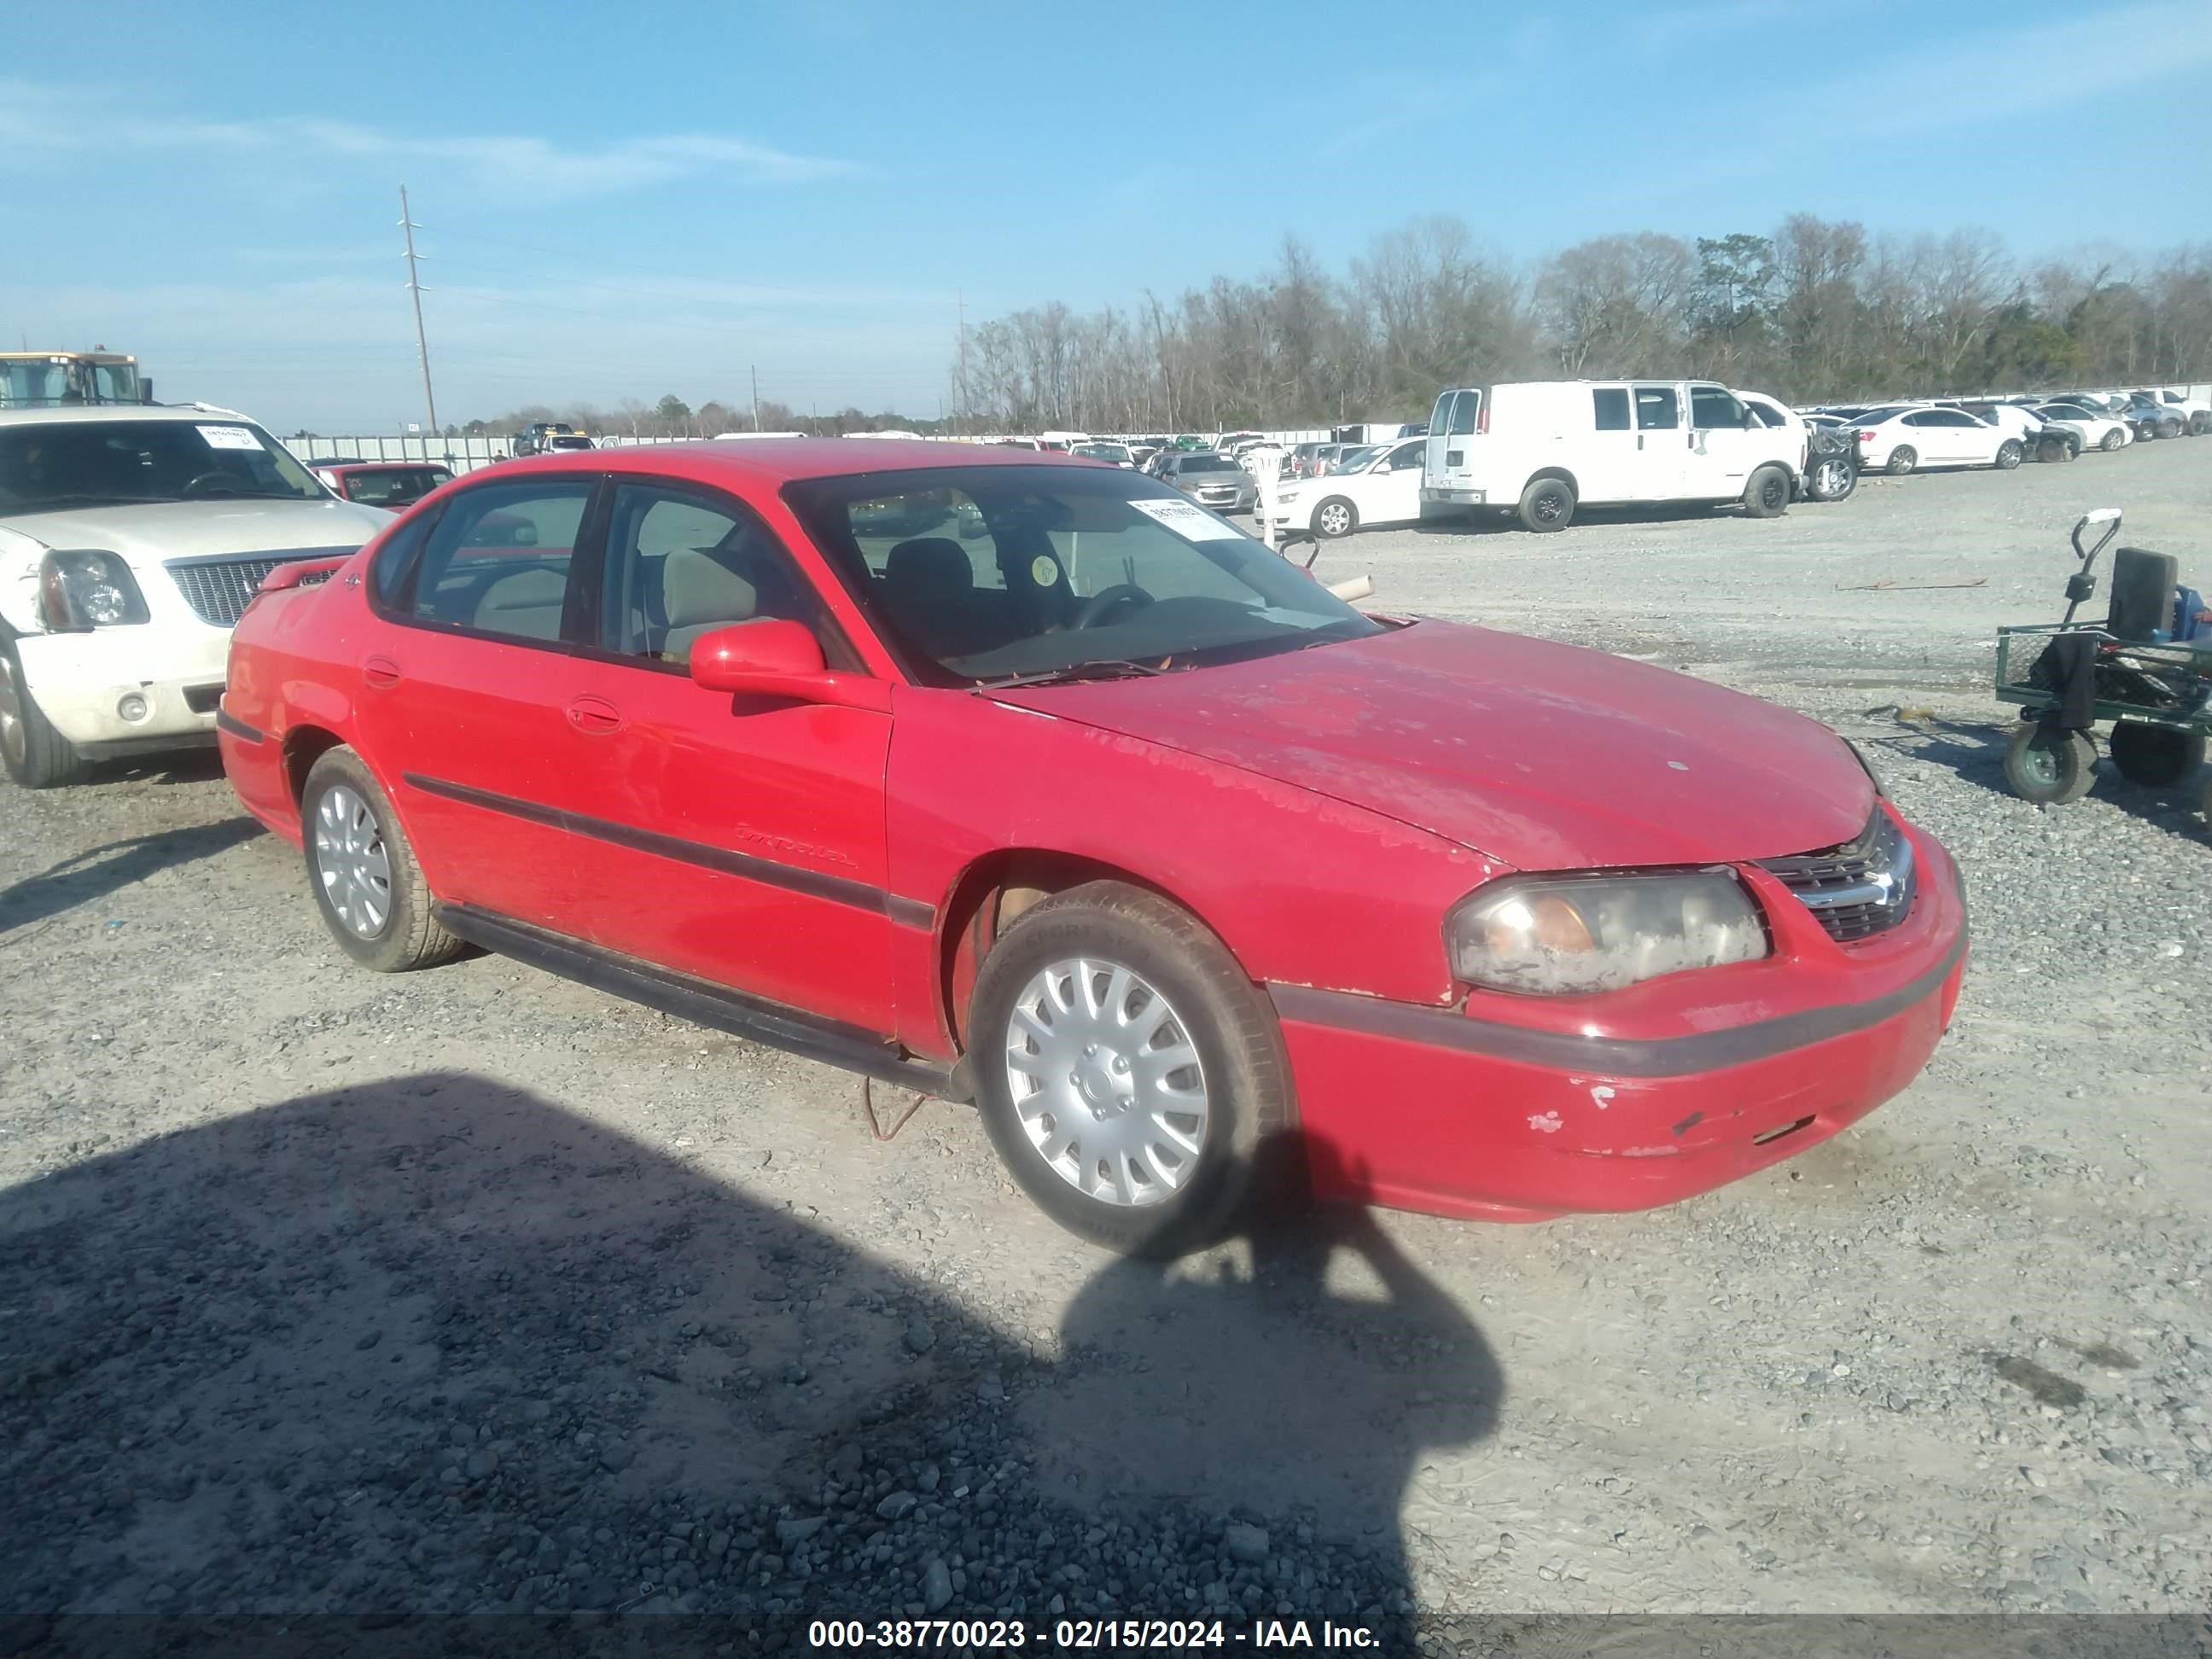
[[1445, 870, 1770, 995]]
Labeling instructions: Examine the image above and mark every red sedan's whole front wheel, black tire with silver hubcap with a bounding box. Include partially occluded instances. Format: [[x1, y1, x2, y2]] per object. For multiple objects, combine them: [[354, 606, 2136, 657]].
[[969, 881, 1289, 1256]]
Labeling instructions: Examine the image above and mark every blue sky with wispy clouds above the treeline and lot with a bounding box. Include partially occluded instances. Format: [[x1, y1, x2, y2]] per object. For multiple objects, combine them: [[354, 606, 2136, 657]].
[[0, 0, 2212, 434]]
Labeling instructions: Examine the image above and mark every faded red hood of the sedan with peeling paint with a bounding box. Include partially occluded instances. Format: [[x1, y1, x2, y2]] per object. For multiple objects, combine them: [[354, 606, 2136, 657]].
[[995, 621, 1873, 870]]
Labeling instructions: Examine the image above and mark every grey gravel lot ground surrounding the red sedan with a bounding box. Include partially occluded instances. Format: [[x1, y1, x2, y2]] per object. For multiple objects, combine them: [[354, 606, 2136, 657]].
[[0, 442, 2212, 1619]]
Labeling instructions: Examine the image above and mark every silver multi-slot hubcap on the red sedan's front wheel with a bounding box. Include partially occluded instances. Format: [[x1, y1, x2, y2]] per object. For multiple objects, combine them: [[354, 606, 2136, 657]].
[[1006, 958, 1210, 1206]]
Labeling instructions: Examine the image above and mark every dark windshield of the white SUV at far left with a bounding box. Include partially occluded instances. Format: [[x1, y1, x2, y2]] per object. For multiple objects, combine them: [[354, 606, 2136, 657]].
[[0, 416, 325, 513]]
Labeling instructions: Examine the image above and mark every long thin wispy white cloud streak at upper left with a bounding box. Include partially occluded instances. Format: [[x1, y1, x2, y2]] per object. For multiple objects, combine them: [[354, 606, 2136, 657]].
[[0, 79, 863, 199]]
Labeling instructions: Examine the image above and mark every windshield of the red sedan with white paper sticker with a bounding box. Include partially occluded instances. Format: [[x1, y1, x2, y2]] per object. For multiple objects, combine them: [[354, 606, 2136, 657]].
[[783, 467, 1382, 686]]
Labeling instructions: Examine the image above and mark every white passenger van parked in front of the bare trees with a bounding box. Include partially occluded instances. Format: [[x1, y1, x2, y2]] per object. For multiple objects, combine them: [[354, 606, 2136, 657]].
[[1420, 381, 1802, 531]]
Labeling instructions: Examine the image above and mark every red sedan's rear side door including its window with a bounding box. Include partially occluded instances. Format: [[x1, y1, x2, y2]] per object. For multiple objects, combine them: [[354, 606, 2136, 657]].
[[354, 474, 599, 927]]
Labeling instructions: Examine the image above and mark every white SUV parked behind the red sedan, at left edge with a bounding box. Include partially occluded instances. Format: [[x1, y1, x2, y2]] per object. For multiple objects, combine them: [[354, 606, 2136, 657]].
[[0, 405, 392, 789]]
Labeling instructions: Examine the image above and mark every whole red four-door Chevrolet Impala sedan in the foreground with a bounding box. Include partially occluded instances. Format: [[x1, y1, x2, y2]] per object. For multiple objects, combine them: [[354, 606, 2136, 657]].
[[221, 440, 1966, 1249]]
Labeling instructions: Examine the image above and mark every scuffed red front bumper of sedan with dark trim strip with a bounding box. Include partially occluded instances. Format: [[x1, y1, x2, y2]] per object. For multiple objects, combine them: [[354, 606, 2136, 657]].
[[1272, 832, 1966, 1221]]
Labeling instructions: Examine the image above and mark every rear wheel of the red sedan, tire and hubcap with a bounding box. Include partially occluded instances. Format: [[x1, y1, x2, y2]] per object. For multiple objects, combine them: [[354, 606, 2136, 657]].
[[299, 748, 464, 973]]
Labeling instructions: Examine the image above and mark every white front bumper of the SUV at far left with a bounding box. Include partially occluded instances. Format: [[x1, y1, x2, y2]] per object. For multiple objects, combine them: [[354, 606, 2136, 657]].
[[15, 621, 230, 754]]
